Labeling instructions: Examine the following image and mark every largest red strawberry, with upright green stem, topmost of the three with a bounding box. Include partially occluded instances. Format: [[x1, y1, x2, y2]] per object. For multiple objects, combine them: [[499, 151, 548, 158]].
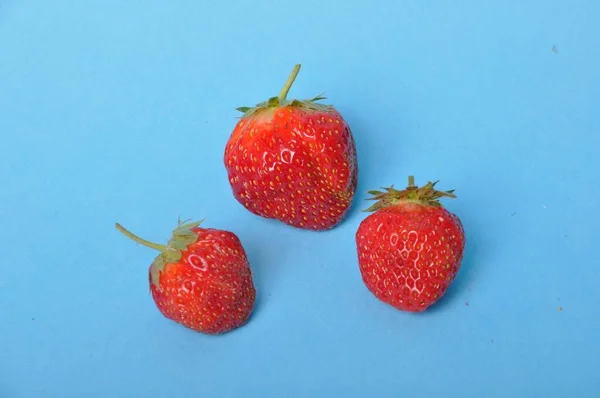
[[224, 65, 358, 230]]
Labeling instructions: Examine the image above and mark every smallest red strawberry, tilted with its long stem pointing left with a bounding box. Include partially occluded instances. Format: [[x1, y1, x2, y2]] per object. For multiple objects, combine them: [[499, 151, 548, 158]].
[[116, 222, 256, 334]]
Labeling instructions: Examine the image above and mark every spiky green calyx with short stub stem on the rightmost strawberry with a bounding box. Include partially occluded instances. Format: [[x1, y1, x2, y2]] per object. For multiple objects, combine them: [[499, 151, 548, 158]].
[[364, 176, 456, 212]]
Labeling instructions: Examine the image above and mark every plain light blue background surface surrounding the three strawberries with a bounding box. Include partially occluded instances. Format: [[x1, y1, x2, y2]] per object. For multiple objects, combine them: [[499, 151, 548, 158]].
[[0, 0, 600, 398]]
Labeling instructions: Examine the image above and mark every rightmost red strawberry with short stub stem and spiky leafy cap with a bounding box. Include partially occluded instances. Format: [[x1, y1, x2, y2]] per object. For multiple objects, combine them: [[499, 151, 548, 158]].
[[356, 176, 465, 312]]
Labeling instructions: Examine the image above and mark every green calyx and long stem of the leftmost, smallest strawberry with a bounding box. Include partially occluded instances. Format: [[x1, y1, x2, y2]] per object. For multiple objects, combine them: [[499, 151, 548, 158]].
[[115, 220, 202, 285]]
